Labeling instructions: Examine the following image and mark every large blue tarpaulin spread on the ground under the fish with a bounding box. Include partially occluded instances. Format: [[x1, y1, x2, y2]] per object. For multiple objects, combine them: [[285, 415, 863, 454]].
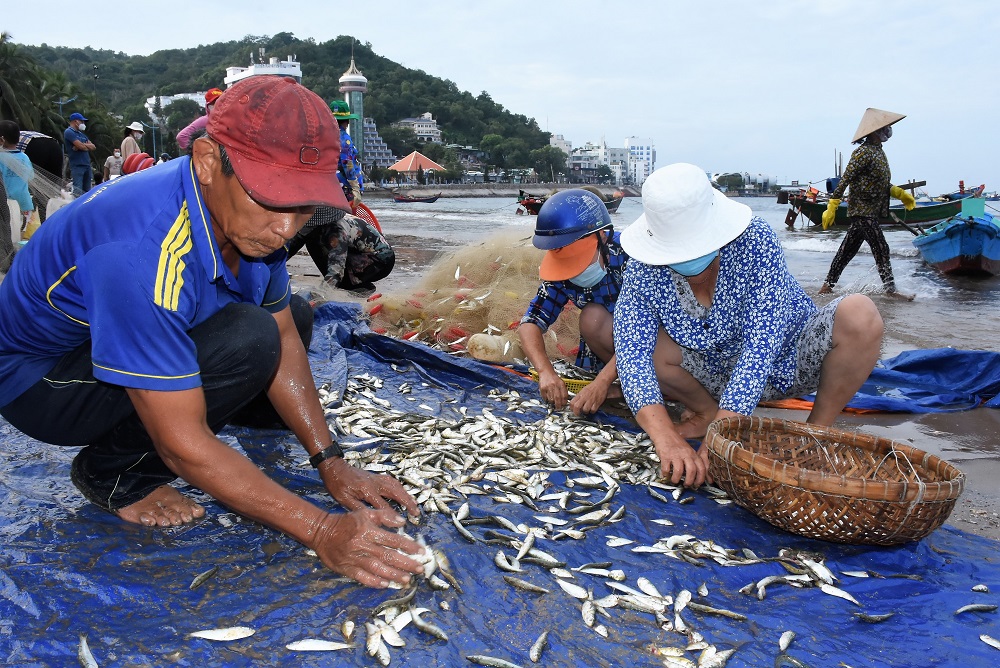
[[0, 304, 1000, 667]]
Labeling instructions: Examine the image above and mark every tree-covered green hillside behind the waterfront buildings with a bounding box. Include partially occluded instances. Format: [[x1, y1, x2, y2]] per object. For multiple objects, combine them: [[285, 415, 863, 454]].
[[9, 33, 549, 175]]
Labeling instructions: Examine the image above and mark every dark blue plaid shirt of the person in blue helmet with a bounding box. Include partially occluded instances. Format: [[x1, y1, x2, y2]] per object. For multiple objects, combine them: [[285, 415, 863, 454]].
[[521, 232, 628, 368]]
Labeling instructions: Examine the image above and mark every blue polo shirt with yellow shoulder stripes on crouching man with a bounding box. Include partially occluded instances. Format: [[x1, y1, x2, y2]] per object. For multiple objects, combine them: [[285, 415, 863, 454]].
[[0, 157, 290, 406]]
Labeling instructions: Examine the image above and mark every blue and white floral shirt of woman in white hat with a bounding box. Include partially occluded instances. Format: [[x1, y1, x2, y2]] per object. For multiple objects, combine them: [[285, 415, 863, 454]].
[[615, 217, 817, 415]]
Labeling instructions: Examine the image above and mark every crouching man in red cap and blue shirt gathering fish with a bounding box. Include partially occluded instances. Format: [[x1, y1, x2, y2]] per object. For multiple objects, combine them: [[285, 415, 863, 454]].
[[0, 77, 421, 587]]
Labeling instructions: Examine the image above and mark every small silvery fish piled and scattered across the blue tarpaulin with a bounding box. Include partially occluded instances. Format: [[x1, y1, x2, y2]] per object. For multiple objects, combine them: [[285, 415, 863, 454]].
[[321, 375, 916, 668]]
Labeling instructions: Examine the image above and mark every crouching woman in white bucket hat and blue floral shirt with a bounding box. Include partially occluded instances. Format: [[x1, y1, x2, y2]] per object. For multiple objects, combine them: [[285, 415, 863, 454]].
[[614, 163, 883, 486]]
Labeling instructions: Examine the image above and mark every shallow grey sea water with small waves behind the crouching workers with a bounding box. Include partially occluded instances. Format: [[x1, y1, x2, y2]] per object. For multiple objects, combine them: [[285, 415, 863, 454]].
[[367, 197, 1000, 357]]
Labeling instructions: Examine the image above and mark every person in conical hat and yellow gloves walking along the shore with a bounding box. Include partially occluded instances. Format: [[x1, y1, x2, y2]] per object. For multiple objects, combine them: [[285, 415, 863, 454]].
[[819, 107, 916, 300]]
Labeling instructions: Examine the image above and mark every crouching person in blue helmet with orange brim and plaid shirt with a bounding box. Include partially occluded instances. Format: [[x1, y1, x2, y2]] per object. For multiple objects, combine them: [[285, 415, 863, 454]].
[[517, 188, 628, 415]]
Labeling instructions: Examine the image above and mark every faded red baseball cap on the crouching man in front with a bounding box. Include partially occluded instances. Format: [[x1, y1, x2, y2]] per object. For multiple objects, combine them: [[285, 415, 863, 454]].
[[207, 75, 351, 211]]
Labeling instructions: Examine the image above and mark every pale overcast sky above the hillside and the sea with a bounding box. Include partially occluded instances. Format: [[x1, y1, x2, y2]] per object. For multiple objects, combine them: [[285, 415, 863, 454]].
[[7, 0, 1000, 194]]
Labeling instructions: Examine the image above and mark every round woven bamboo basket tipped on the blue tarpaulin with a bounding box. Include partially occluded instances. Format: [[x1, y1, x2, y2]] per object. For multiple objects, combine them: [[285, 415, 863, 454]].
[[705, 416, 965, 545]]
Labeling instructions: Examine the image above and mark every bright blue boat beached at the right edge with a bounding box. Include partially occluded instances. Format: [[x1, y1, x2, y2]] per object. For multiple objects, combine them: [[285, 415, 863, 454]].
[[913, 213, 1000, 276]]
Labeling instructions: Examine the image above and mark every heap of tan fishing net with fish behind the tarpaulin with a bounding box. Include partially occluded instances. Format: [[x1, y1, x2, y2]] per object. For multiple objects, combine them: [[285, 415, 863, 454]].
[[365, 229, 580, 362]]
